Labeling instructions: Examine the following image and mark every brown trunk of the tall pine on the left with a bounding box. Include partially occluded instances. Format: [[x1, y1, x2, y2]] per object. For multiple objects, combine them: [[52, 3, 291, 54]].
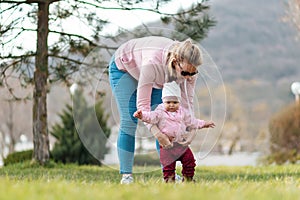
[[33, 1, 49, 165]]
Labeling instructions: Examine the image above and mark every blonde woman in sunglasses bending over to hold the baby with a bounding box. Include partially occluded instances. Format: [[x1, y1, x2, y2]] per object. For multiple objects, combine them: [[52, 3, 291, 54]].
[[109, 36, 202, 184]]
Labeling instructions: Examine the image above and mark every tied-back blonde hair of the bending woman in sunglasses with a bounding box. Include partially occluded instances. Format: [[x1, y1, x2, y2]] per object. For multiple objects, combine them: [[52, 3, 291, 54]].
[[166, 39, 202, 81]]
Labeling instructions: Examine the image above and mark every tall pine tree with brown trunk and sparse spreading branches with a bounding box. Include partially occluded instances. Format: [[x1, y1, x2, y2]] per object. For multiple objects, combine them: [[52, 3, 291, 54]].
[[0, 0, 215, 164]]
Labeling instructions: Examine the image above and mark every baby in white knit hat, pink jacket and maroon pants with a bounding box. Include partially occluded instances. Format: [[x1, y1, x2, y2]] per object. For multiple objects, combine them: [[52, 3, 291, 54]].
[[133, 81, 215, 182]]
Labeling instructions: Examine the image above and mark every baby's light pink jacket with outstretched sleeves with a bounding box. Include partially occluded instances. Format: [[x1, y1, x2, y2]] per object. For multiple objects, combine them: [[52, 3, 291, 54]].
[[142, 104, 205, 142]]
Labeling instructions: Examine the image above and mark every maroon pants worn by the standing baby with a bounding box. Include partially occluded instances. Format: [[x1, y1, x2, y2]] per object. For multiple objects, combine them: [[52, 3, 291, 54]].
[[160, 143, 196, 182]]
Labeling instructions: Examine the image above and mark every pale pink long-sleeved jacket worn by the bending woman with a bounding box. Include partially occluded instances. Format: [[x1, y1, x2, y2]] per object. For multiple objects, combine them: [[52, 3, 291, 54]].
[[115, 36, 197, 111]]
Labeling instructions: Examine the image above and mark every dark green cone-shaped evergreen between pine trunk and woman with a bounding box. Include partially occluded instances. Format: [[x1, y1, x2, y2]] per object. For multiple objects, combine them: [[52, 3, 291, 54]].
[[50, 91, 110, 165]]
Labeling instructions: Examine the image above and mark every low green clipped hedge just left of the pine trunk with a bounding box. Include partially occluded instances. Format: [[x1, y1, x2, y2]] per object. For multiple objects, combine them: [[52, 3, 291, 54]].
[[3, 149, 33, 166]]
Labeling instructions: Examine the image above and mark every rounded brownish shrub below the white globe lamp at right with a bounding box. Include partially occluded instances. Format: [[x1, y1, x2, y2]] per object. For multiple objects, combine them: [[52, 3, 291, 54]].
[[267, 104, 300, 164]]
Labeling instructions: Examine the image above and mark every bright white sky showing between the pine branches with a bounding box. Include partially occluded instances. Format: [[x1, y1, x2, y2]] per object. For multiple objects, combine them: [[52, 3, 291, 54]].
[[1, 0, 201, 53]]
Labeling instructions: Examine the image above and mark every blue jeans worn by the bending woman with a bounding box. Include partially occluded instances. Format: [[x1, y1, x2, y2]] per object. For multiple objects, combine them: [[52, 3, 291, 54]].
[[109, 56, 162, 174]]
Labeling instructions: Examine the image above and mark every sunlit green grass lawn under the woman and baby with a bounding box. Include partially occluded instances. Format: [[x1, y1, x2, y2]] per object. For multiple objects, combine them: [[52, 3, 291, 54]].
[[0, 163, 300, 200]]
